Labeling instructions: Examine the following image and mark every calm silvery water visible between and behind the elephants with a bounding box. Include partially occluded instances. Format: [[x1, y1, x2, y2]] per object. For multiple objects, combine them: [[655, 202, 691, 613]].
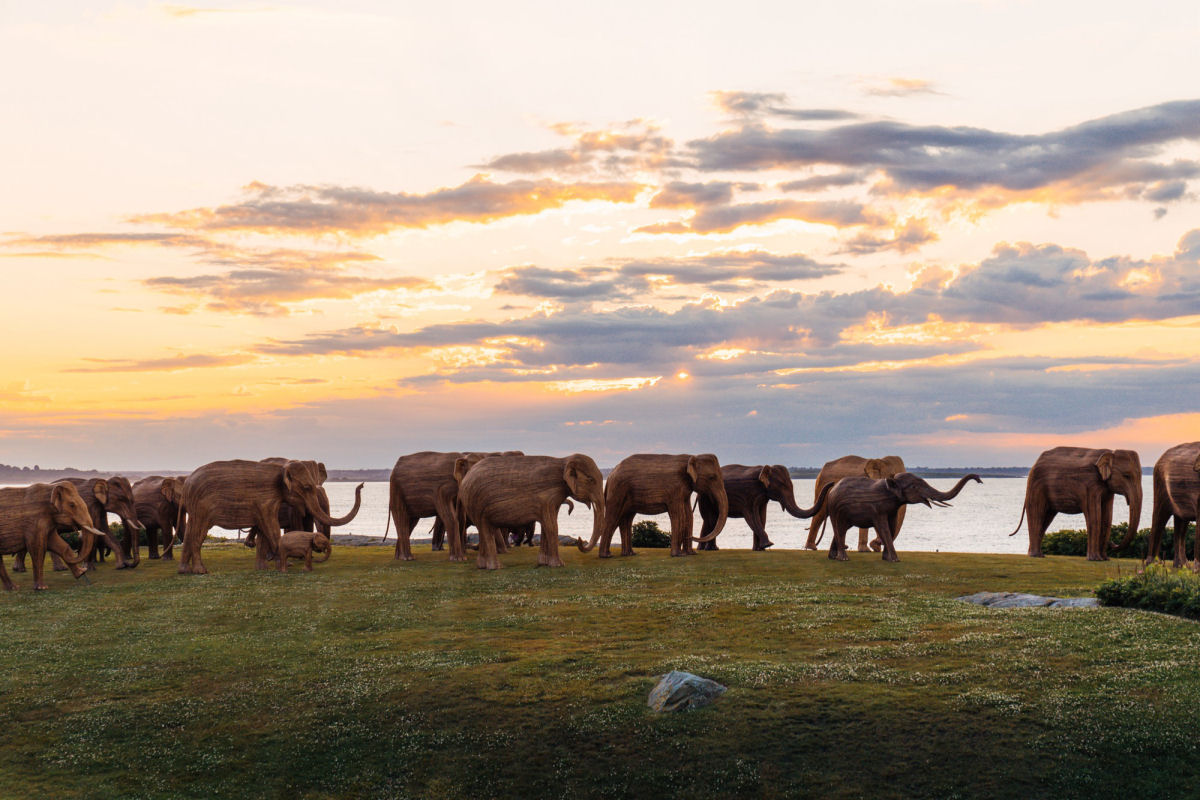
[[325, 475, 1151, 558]]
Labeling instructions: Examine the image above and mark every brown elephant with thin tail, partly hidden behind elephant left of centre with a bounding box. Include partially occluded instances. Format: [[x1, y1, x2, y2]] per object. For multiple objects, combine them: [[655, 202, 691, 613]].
[[384, 451, 485, 561]]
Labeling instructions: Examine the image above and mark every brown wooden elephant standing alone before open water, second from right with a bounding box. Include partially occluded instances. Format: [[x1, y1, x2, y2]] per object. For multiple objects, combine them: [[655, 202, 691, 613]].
[[1009, 447, 1141, 561]]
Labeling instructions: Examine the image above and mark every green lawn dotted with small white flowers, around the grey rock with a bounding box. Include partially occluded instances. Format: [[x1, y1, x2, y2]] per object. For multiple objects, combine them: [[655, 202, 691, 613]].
[[0, 546, 1200, 799]]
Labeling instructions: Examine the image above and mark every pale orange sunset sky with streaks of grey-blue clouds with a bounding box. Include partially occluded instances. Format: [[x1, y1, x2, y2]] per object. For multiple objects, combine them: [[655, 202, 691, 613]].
[[0, 0, 1200, 469]]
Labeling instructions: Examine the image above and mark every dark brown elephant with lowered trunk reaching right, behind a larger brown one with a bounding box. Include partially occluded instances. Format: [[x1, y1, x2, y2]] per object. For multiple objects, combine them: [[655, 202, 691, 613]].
[[696, 464, 833, 551]]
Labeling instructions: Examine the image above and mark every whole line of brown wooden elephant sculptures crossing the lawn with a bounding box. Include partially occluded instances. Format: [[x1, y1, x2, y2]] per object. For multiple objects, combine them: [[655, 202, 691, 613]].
[[0, 441, 1200, 590]]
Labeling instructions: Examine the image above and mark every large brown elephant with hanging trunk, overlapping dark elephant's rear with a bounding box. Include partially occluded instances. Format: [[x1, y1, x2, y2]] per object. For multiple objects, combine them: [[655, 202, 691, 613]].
[[580, 453, 730, 558]]
